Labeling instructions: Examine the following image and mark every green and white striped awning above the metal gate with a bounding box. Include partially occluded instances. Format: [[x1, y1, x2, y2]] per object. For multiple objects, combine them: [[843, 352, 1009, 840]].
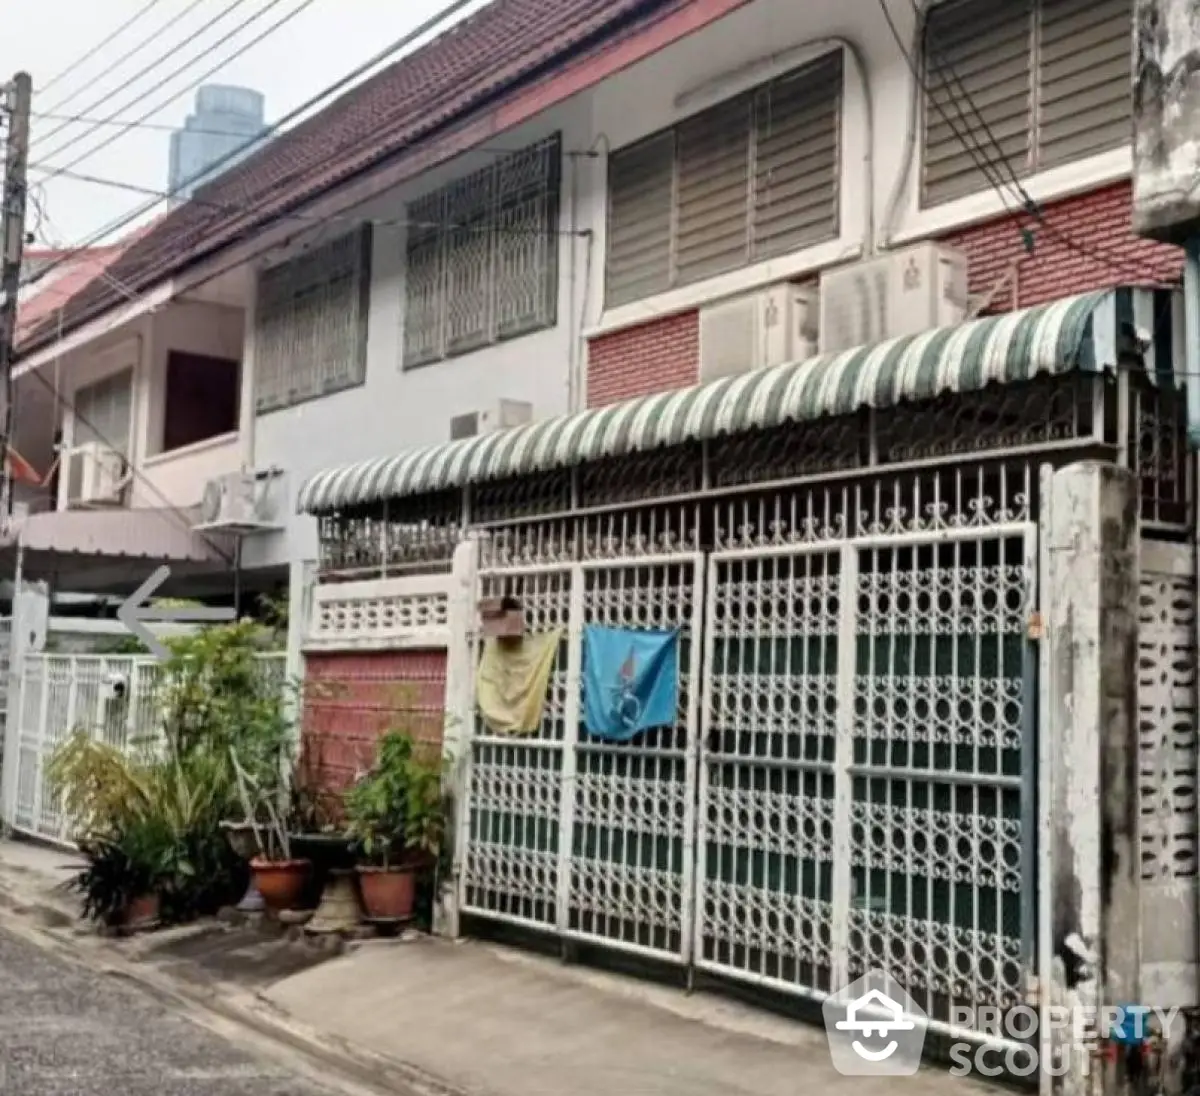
[[296, 289, 1153, 513]]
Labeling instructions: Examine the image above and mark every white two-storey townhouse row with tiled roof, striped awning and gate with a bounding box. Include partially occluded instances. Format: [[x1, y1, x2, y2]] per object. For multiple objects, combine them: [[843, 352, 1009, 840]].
[[7, 0, 1196, 1065]]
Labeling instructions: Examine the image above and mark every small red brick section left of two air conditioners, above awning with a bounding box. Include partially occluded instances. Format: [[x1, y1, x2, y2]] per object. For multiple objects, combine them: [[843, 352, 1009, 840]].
[[588, 311, 700, 407]]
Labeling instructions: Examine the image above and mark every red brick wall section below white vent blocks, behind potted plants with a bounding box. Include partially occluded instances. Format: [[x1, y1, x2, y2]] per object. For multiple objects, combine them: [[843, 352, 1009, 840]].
[[302, 651, 446, 792]]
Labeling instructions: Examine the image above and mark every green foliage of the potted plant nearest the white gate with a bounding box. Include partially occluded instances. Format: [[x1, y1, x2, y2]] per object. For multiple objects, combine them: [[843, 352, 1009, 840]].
[[346, 731, 445, 868]]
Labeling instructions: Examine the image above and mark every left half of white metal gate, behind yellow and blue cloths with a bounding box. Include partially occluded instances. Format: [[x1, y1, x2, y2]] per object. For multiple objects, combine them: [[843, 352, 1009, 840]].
[[461, 555, 703, 962]]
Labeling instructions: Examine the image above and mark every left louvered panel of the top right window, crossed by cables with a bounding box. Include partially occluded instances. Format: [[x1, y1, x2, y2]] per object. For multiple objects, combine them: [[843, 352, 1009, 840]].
[[922, 0, 1033, 205]]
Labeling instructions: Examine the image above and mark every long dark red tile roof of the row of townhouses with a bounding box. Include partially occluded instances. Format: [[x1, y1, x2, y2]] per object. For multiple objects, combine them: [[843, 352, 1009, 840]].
[[19, 0, 691, 352]]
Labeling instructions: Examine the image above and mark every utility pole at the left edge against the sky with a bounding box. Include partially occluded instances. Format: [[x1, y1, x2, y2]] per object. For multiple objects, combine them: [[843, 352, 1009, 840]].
[[0, 72, 34, 517]]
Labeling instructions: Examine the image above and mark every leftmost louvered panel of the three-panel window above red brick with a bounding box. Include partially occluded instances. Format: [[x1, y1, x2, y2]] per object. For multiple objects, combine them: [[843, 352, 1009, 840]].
[[606, 131, 674, 306]]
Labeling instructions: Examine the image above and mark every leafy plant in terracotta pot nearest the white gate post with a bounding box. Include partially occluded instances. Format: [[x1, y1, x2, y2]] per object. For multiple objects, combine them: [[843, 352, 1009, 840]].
[[346, 731, 445, 921]]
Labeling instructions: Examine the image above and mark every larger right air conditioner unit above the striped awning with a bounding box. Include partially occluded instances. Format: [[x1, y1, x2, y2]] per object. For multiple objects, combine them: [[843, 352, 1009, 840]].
[[820, 244, 967, 353]]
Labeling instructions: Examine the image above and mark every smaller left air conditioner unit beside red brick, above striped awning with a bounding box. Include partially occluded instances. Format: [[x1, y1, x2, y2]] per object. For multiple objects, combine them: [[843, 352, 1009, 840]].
[[700, 282, 817, 381]]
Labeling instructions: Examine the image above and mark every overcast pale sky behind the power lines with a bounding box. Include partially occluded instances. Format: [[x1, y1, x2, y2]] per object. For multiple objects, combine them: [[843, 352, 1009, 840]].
[[0, 0, 487, 246]]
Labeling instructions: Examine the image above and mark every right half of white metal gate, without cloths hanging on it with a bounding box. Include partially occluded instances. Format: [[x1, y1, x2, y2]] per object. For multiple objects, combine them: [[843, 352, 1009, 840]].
[[695, 523, 1037, 1022]]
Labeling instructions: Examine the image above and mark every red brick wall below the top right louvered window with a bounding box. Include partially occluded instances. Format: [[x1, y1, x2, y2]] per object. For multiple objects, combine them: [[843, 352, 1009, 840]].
[[943, 182, 1183, 312]]
